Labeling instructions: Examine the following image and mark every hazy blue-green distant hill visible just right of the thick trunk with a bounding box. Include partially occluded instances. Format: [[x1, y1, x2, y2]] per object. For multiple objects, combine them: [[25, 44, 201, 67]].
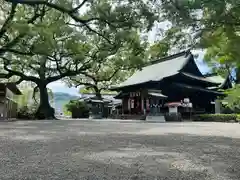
[[53, 92, 80, 111]]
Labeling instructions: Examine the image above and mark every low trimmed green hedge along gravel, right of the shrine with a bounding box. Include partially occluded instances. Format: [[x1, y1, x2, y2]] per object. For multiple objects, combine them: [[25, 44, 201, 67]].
[[193, 114, 238, 122]]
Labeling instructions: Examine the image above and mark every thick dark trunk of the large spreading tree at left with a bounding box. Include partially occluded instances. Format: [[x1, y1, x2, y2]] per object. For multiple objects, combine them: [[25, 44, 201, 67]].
[[36, 84, 55, 119]]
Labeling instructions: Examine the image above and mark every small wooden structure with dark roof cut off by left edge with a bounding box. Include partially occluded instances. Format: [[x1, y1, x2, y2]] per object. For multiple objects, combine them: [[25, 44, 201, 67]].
[[0, 83, 21, 120]]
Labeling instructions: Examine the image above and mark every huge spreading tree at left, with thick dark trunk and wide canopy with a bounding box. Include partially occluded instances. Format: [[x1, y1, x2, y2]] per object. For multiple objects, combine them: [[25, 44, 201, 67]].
[[0, 0, 156, 118]]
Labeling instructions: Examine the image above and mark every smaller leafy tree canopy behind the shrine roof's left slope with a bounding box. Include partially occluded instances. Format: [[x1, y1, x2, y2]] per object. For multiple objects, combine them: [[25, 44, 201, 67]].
[[64, 31, 147, 99]]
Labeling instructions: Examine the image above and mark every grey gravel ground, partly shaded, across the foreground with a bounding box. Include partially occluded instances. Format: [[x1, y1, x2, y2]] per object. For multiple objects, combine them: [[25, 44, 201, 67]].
[[0, 120, 240, 180]]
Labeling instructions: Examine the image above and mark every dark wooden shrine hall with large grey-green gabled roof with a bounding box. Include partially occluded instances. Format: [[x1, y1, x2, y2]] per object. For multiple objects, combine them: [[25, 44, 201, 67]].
[[112, 51, 232, 114]]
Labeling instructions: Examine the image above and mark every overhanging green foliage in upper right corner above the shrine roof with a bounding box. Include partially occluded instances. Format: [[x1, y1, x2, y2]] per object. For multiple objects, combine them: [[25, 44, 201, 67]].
[[160, 0, 240, 79]]
